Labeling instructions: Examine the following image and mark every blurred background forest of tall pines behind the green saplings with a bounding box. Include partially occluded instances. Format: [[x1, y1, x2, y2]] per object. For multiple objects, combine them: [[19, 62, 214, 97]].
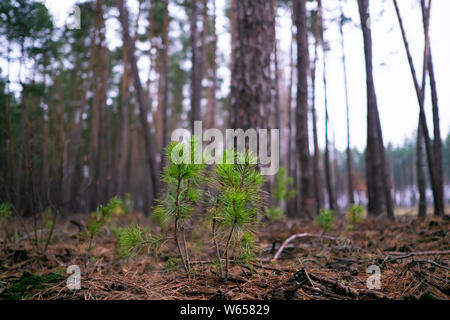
[[0, 0, 450, 216]]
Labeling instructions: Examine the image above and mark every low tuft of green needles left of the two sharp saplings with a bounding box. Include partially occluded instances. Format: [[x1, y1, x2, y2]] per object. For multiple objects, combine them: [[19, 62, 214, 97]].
[[114, 225, 164, 258]]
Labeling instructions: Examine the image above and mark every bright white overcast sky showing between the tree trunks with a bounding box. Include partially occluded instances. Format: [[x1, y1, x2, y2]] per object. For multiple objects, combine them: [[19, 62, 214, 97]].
[[7, 0, 450, 150]]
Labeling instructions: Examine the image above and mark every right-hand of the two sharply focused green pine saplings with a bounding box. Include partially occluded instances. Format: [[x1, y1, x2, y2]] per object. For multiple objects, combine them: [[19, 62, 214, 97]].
[[212, 150, 264, 278]]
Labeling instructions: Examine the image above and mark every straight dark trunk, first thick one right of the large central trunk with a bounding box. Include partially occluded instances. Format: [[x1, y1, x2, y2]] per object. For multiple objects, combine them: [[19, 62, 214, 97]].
[[294, 0, 314, 217]]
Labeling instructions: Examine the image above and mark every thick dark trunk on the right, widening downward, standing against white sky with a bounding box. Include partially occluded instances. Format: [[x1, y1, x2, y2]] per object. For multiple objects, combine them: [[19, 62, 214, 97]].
[[358, 0, 394, 219]]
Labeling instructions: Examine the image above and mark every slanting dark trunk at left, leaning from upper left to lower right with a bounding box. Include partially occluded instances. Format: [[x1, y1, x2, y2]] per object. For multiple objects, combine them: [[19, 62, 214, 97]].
[[116, 0, 159, 204]]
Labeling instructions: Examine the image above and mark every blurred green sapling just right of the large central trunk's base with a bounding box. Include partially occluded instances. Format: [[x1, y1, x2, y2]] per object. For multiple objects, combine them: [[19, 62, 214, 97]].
[[266, 167, 297, 221]]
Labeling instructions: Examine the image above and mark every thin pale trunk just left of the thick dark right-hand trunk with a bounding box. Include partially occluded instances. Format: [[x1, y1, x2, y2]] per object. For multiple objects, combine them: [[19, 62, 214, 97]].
[[339, 0, 355, 205]]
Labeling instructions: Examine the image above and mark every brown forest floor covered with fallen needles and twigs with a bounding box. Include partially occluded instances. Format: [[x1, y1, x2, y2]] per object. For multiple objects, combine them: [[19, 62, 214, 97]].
[[0, 214, 450, 300]]
